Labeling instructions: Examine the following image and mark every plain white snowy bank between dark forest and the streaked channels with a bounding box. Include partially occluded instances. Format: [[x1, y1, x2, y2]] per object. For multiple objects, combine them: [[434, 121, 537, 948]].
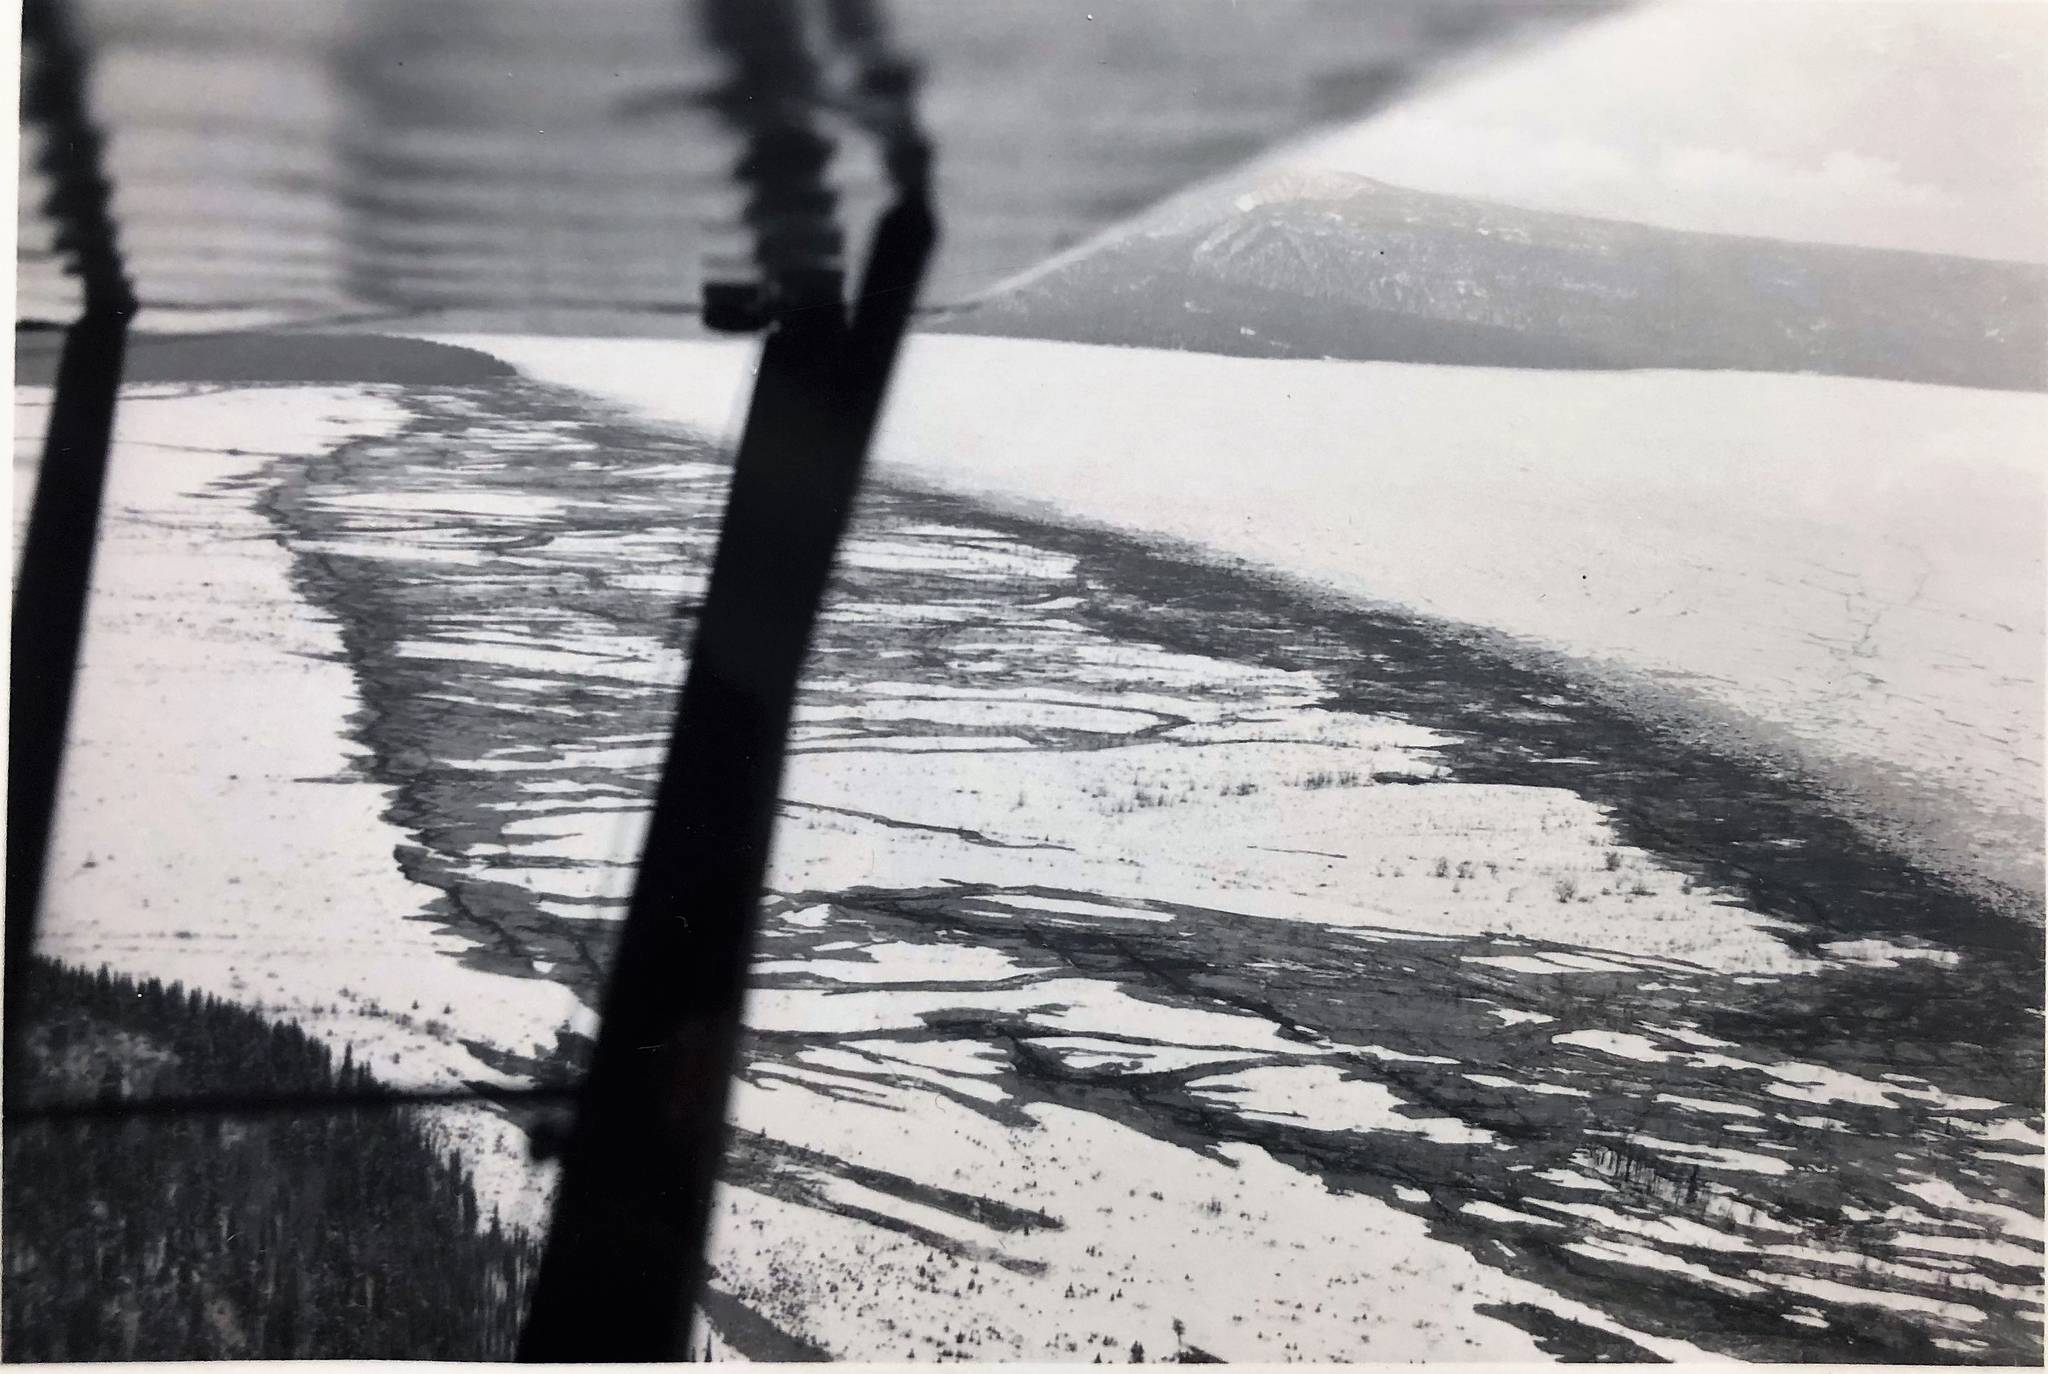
[[14, 387, 580, 1222]]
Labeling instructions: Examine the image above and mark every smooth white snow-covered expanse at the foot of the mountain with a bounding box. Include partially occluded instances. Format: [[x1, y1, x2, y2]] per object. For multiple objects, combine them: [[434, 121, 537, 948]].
[[446, 336, 2048, 905]]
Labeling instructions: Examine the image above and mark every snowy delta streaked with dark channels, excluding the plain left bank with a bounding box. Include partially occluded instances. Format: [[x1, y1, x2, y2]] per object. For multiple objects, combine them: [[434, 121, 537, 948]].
[[251, 383, 2038, 1358]]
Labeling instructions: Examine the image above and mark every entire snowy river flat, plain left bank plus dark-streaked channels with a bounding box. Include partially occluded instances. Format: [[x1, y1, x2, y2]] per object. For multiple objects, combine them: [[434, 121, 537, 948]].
[[16, 373, 2040, 1360]]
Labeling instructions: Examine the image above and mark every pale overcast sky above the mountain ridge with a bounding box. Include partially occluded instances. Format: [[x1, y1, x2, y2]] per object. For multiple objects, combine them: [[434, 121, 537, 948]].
[[1284, 0, 2048, 260]]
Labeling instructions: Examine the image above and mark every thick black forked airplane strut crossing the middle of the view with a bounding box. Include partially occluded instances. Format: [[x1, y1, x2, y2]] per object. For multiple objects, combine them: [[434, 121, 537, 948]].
[[518, 0, 936, 1362]]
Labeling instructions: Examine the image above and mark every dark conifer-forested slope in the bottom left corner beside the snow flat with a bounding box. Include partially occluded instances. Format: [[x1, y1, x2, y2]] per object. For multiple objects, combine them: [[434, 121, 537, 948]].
[[0, 964, 539, 1362]]
